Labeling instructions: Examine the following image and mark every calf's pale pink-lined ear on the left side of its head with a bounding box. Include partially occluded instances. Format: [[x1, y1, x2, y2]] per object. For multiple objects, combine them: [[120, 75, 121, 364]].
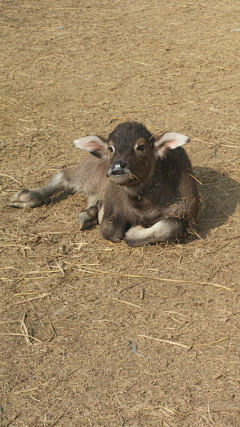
[[73, 135, 108, 157]]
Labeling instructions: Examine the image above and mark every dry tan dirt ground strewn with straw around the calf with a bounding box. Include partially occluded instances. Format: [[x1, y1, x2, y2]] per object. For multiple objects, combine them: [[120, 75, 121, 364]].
[[0, 0, 240, 427]]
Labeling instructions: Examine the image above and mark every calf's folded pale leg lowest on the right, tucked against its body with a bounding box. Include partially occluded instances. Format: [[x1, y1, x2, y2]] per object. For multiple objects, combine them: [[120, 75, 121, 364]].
[[125, 218, 185, 246]]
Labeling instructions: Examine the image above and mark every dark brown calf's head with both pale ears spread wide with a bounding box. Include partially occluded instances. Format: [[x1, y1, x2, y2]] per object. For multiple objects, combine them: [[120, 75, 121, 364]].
[[74, 122, 189, 186]]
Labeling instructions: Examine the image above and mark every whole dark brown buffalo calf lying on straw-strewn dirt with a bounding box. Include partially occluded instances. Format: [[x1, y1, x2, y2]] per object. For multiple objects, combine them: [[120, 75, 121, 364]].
[[11, 122, 200, 246]]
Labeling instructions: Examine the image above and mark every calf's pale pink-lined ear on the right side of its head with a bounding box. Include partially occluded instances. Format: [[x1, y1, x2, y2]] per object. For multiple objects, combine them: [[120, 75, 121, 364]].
[[154, 132, 190, 157]]
